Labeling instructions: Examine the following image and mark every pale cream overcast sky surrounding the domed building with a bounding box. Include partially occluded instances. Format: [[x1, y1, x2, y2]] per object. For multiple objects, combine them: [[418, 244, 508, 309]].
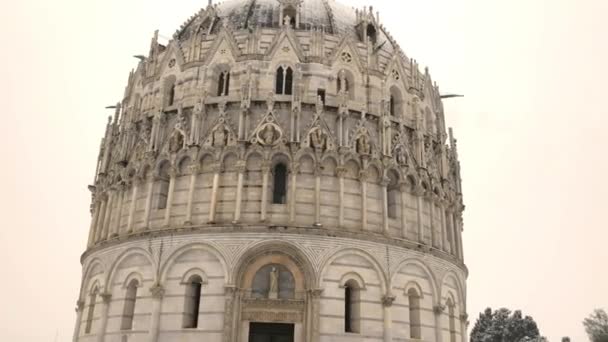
[[0, 0, 608, 342]]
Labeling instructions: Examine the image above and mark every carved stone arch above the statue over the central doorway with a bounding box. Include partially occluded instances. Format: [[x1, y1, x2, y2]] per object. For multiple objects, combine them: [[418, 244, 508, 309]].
[[231, 240, 318, 291]]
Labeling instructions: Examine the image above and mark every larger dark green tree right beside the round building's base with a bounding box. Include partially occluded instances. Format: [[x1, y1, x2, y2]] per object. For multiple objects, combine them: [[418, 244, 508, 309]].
[[471, 308, 544, 342]]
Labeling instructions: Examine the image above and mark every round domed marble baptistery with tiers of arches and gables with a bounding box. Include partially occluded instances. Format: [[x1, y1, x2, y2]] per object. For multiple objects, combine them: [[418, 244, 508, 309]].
[[73, 0, 468, 342]]
